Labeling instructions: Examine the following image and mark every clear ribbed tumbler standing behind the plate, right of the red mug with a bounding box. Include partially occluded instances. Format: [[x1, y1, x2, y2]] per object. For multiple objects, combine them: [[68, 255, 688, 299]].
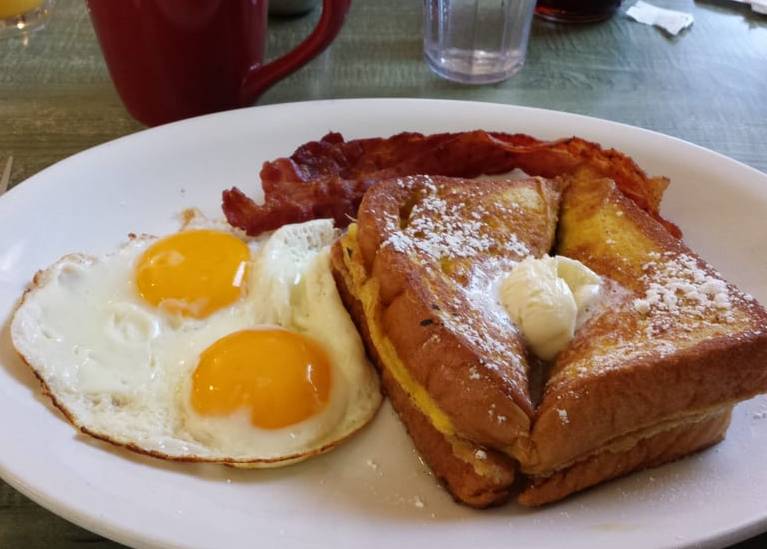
[[423, 0, 535, 84]]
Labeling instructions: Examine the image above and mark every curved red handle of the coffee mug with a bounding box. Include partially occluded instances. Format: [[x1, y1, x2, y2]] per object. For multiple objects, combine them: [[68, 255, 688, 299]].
[[240, 0, 351, 107]]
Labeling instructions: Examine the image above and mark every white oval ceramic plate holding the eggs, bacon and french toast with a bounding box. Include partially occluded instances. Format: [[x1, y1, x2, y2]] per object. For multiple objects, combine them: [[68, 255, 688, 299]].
[[0, 100, 767, 549]]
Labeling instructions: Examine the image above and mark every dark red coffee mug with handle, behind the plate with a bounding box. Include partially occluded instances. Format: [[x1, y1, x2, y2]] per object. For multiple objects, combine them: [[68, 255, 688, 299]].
[[87, 0, 351, 126]]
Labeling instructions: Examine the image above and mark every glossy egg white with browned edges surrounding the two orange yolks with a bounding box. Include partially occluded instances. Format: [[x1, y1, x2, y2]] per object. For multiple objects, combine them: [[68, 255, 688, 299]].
[[11, 216, 381, 466]]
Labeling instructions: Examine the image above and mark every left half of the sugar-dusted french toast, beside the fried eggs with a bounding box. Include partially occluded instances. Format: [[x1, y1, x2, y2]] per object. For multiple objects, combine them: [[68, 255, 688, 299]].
[[332, 176, 560, 507]]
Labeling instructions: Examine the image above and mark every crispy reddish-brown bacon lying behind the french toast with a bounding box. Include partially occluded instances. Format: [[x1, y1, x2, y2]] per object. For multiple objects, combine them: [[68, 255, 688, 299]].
[[223, 130, 681, 236]]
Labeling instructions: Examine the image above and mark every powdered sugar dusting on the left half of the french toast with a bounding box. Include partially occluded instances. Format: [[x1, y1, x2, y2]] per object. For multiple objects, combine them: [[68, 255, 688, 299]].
[[382, 176, 530, 382]]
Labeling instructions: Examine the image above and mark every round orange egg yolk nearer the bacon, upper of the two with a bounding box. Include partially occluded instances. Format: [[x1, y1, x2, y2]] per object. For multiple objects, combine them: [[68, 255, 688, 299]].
[[136, 230, 250, 318]]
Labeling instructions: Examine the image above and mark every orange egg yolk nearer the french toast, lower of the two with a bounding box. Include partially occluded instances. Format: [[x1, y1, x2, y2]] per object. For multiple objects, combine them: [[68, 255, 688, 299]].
[[191, 328, 331, 429]]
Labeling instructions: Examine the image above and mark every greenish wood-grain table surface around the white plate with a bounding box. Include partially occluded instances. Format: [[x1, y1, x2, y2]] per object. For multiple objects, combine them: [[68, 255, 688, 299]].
[[0, 0, 767, 548]]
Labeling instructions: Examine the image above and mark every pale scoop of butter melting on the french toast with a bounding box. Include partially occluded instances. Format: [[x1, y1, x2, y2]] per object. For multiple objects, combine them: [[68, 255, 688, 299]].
[[500, 256, 602, 360]]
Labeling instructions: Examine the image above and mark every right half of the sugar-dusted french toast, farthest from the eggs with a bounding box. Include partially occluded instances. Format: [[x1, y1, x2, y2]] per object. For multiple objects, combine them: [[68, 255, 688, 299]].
[[520, 179, 767, 505]]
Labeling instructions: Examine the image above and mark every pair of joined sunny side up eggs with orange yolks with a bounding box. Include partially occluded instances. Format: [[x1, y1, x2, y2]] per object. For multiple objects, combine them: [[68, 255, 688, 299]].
[[11, 215, 381, 467]]
